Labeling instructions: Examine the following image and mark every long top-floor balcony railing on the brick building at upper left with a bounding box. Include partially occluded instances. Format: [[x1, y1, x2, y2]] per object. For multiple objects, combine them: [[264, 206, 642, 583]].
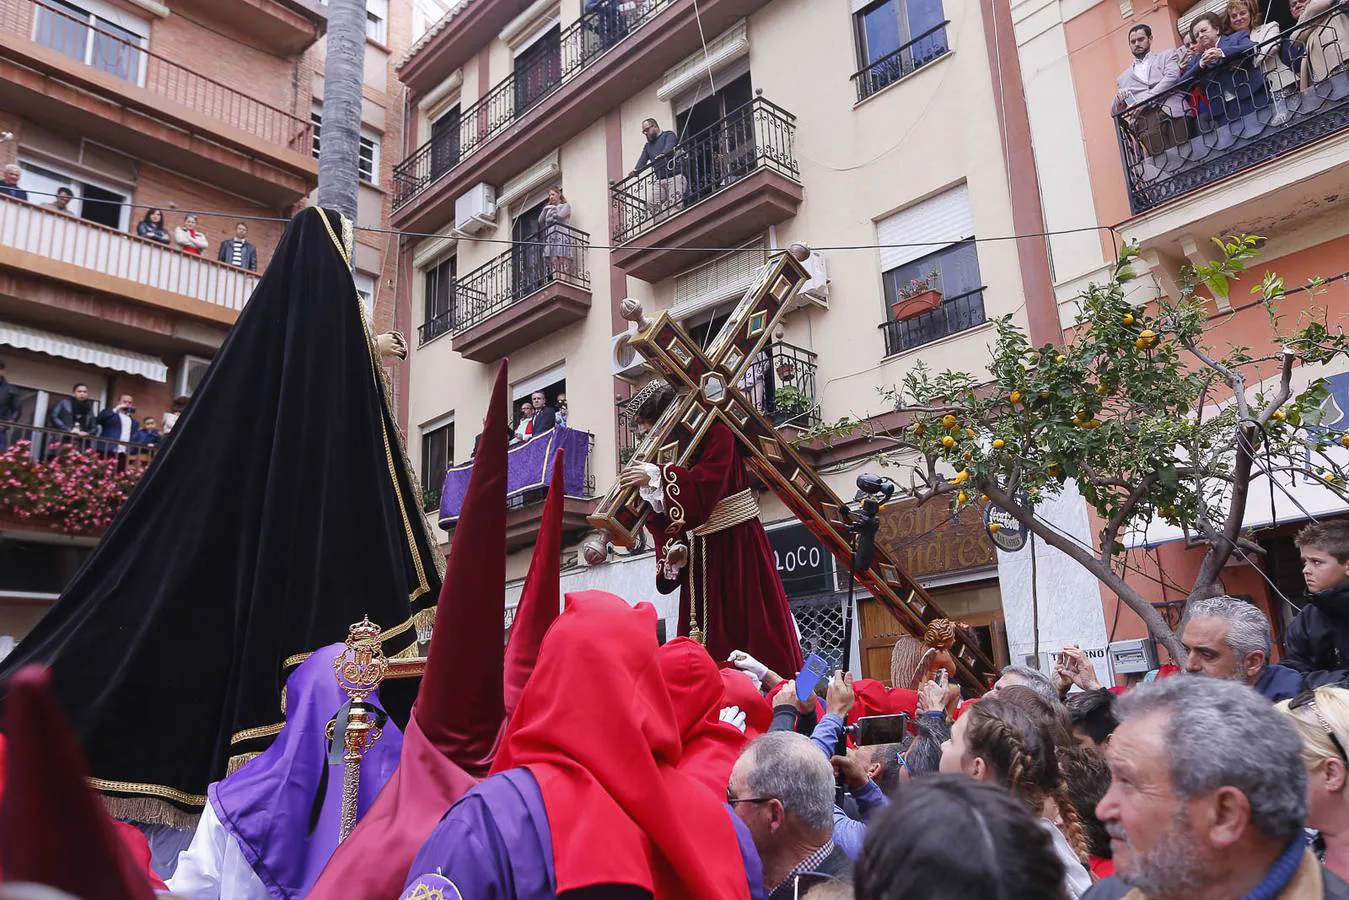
[[0, 0, 310, 157]]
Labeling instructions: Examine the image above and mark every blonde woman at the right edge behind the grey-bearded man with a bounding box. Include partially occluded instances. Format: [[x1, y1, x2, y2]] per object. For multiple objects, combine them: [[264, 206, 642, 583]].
[[1275, 687, 1349, 878]]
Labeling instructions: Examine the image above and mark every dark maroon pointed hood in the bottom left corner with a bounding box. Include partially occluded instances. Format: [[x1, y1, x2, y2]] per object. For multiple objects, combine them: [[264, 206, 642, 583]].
[[0, 665, 154, 900]]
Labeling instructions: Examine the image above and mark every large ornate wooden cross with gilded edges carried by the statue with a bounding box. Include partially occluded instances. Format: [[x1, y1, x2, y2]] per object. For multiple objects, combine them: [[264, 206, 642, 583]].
[[590, 254, 996, 692]]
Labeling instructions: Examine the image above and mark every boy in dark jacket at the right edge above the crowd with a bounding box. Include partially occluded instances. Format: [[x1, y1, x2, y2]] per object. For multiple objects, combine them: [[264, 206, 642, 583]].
[[1280, 522, 1349, 687]]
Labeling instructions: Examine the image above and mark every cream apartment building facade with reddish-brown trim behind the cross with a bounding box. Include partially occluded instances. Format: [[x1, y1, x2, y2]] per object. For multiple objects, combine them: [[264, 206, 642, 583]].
[[391, 0, 1105, 677]]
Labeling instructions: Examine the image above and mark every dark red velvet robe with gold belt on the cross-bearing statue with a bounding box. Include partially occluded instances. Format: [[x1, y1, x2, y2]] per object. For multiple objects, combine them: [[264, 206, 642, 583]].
[[646, 422, 801, 677]]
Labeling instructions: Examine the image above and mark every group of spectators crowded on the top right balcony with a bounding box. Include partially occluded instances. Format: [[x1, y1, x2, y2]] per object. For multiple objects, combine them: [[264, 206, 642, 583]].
[[1112, 0, 1349, 155]]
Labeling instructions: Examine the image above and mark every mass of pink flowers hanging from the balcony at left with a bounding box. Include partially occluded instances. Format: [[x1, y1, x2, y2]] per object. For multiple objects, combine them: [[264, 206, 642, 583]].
[[0, 441, 148, 534]]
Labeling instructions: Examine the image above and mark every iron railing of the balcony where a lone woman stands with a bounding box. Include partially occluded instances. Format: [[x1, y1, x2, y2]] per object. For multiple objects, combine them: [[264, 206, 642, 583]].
[[448, 225, 590, 335]]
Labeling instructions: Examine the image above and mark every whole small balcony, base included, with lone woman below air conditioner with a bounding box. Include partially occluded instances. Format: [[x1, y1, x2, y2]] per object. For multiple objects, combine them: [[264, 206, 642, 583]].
[[447, 225, 591, 363]]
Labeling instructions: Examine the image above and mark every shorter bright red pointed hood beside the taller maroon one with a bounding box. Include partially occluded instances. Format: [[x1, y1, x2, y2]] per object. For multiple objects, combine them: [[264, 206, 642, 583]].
[[505, 448, 565, 718]]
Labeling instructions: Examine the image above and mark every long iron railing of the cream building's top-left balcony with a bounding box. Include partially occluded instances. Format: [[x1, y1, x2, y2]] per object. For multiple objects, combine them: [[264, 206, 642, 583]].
[[394, 0, 675, 209]]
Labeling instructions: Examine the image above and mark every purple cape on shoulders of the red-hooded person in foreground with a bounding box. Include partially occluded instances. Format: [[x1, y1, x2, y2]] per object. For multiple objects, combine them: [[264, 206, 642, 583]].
[[403, 769, 768, 900]]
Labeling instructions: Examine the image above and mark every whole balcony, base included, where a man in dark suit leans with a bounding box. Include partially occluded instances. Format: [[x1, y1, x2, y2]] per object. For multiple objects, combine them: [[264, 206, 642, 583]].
[[610, 96, 803, 281]]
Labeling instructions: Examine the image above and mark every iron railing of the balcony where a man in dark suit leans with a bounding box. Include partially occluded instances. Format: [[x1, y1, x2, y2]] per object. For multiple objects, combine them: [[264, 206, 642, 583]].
[[610, 97, 800, 244]]
